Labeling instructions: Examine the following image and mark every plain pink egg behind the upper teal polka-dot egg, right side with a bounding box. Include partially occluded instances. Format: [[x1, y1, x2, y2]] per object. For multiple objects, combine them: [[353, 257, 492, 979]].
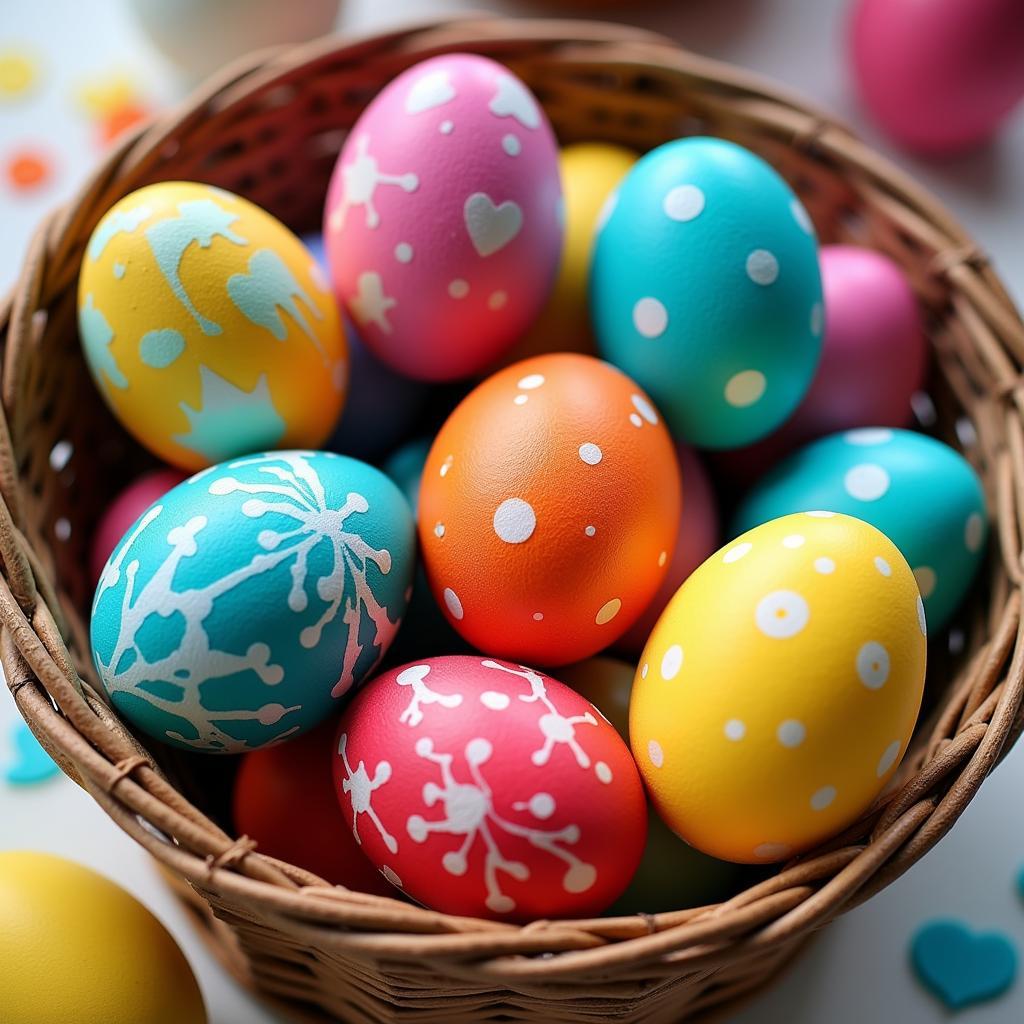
[[715, 246, 928, 481]]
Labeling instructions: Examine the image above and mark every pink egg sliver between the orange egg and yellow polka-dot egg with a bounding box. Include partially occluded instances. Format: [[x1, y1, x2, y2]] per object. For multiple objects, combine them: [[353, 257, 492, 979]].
[[614, 443, 719, 655]]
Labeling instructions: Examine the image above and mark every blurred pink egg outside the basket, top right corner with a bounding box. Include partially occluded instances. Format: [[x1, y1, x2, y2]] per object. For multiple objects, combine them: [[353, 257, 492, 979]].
[[850, 0, 1024, 154]]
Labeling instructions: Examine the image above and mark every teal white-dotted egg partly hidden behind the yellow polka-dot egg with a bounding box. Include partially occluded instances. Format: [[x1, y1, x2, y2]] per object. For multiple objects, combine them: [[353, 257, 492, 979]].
[[731, 427, 988, 632]]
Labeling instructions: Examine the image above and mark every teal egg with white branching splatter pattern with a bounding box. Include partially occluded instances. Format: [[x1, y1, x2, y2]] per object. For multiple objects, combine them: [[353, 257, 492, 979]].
[[91, 452, 416, 753]]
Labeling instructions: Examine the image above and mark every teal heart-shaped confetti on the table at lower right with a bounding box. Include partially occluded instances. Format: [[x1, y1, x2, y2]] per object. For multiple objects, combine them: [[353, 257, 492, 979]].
[[910, 920, 1017, 1010]]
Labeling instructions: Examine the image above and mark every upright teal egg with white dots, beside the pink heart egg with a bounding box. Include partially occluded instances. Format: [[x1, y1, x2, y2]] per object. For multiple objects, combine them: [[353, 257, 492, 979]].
[[590, 138, 823, 449]]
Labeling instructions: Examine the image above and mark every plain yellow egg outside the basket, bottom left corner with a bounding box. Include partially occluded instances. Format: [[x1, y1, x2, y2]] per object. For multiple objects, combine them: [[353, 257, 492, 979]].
[[0, 851, 207, 1024]]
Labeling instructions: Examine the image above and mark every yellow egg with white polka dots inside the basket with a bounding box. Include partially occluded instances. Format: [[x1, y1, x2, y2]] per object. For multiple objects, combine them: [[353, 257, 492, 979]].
[[630, 512, 927, 863]]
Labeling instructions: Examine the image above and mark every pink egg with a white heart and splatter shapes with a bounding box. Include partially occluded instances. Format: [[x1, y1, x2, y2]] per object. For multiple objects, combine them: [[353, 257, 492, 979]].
[[324, 54, 562, 381]]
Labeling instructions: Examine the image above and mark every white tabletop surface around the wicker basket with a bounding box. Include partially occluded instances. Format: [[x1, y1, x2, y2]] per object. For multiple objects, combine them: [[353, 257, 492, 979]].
[[0, 0, 1024, 1024]]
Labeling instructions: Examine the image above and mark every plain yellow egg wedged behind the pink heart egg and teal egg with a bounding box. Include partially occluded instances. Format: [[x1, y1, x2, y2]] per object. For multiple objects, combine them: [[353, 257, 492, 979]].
[[496, 142, 640, 369]]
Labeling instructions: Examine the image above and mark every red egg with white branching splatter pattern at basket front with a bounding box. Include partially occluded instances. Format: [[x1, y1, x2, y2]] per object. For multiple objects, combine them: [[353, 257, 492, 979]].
[[334, 656, 647, 921]]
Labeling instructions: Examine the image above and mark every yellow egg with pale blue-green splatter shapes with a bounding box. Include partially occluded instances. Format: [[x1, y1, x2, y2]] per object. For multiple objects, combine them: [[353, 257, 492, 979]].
[[78, 181, 348, 470]]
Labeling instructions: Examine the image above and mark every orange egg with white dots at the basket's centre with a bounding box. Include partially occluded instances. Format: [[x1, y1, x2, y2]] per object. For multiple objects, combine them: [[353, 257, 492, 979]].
[[419, 352, 680, 665]]
